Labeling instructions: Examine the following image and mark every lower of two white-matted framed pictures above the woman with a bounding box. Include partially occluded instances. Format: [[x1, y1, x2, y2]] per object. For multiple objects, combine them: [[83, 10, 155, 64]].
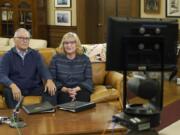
[[55, 10, 71, 26]]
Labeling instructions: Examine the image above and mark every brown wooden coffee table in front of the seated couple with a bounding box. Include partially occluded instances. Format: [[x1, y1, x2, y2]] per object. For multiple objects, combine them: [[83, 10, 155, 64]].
[[0, 103, 126, 135]]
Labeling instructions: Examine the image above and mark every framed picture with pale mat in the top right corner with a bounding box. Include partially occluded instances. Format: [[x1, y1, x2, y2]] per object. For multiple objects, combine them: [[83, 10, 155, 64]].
[[166, 0, 180, 17]]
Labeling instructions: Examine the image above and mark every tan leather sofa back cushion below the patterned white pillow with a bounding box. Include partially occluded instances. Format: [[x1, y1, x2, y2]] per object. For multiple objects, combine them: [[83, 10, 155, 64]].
[[92, 62, 106, 85]]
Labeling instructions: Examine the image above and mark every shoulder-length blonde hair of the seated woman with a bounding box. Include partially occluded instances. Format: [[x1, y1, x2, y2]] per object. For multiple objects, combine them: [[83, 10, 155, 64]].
[[57, 32, 84, 55]]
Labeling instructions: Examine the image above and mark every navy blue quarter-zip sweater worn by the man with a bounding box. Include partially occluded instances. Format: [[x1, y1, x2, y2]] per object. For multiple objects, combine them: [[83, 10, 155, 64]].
[[0, 47, 52, 90]]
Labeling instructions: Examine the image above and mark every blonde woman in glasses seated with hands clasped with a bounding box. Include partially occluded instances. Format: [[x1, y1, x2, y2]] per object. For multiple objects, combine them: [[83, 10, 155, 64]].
[[50, 32, 93, 104]]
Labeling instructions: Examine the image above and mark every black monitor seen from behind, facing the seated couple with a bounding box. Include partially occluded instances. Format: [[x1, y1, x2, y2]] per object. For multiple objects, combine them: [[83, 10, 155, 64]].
[[106, 17, 178, 71]]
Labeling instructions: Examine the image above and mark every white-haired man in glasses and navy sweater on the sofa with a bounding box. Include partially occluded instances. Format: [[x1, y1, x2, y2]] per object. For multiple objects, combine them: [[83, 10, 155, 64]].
[[0, 28, 56, 108]]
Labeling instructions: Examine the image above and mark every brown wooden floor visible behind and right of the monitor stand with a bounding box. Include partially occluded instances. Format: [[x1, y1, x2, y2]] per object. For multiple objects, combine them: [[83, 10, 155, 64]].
[[130, 81, 180, 106]]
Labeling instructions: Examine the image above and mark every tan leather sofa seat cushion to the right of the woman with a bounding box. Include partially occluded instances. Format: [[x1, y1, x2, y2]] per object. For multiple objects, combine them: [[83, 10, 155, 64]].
[[91, 85, 119, 103]]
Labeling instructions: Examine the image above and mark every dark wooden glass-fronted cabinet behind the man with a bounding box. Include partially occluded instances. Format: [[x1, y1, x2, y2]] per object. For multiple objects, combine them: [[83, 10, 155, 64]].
[[0, 0, 47, 39]]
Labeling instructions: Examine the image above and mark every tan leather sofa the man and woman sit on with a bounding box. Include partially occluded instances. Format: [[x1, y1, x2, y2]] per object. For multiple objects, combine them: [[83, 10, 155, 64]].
[[0, 46, 123, 109]]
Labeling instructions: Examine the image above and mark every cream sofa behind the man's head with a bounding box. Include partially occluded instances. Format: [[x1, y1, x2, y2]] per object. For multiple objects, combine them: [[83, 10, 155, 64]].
[[0, 37, 47, 51]]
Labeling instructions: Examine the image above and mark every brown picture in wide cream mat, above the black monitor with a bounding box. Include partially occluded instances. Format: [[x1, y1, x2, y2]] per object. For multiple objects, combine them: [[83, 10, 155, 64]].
[[144, 0, 161, 14]]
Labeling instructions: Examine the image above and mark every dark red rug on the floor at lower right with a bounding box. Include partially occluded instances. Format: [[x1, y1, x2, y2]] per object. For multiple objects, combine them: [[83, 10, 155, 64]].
[[156, 100, 180, 131]]
